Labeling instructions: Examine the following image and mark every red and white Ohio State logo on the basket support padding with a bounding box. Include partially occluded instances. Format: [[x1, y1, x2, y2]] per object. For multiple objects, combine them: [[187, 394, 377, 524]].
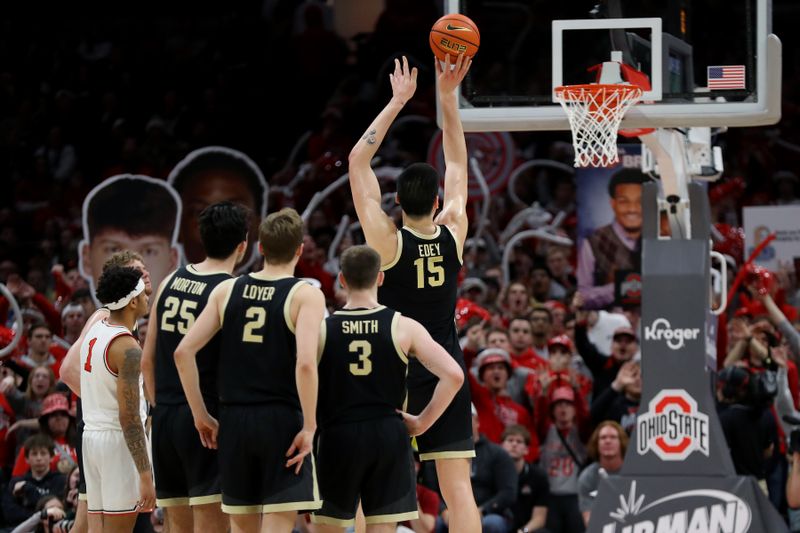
[[636, 389, 708, 461]]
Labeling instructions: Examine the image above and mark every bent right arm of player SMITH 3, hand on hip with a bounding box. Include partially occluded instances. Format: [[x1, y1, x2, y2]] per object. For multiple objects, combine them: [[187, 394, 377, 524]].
[[400, 317, 464, 437]]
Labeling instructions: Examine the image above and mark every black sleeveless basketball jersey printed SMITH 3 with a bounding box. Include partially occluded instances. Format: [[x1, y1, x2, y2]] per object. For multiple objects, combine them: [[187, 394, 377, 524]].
[[317, 306, 408, 428]]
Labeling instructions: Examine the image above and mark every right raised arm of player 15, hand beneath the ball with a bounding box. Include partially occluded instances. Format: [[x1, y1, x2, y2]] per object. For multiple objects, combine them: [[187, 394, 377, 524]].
[[436, 54, 472, 248]]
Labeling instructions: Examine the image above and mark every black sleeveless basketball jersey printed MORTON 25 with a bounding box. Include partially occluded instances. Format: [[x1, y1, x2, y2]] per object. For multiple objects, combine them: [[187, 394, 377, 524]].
[[155, 265, 231, 405]]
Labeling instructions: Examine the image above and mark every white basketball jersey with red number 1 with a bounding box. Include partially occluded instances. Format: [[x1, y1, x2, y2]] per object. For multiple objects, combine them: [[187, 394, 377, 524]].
[[81, 319, 147, 431]]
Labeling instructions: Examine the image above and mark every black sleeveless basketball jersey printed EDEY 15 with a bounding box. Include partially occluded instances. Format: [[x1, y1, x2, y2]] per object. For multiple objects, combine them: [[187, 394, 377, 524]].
[[378, 225, 461, 347]]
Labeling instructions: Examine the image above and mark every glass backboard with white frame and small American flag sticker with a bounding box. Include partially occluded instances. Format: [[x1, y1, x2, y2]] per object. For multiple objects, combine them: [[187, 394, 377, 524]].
[[445, 0, 781, 131]]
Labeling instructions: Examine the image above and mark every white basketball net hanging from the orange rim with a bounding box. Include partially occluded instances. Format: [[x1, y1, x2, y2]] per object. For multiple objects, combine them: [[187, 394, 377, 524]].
[[555, 84, 642, 167]]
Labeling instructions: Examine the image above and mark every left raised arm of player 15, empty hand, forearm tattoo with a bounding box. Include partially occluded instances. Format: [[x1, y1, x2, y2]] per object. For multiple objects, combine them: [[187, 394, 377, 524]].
[[349, 57, 417, 264]]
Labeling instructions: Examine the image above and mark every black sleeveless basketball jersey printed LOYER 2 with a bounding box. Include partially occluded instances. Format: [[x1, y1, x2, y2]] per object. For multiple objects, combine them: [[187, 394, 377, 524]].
[[219, 274, 305, 410]]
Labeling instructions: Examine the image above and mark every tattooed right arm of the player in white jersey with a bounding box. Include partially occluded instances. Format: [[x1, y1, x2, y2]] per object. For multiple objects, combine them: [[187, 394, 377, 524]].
[[117, 348, 150, 473]]
